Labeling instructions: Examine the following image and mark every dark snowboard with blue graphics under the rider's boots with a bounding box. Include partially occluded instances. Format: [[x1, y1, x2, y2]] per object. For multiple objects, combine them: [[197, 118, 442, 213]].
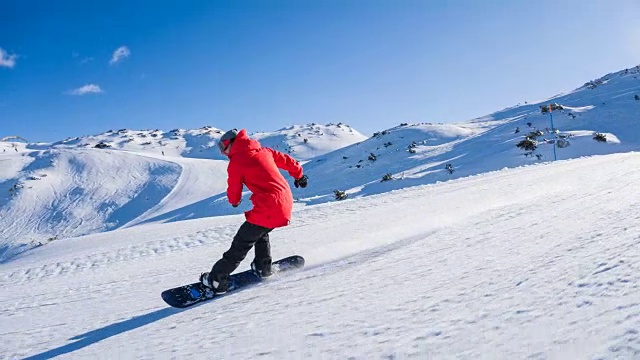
[[161, 255, 304, 308]]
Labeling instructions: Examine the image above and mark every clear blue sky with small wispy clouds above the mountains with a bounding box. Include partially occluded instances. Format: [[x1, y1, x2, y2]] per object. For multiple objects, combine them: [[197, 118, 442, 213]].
[[0, 0, 640, 141]]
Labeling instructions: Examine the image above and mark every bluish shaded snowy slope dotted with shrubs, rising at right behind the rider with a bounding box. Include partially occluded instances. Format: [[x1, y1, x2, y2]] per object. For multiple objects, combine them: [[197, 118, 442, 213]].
[[296, 66, 640, 204]]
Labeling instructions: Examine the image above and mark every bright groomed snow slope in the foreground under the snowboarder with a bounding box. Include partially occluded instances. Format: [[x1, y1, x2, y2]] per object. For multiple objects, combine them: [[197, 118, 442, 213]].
[[0, 153, 640, 359]]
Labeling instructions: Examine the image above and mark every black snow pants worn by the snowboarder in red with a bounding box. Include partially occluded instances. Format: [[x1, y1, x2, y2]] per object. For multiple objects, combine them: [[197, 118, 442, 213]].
[[211, 221, 273, 279]]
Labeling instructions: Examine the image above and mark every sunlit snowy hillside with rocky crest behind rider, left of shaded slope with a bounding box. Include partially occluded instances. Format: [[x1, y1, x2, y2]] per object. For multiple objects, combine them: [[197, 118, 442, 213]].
[[0, 124, 366, 261]]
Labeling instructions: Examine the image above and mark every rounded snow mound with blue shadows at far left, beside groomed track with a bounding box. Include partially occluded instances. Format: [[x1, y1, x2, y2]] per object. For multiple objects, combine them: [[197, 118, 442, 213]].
[[0, 149, 180, 257]]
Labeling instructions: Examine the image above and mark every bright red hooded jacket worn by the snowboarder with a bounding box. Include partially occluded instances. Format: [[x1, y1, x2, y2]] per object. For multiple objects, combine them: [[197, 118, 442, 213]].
[[227, 129, 302, 228]]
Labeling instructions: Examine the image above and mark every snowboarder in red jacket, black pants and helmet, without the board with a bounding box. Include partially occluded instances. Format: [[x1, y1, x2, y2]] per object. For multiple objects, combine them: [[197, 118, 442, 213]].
[[200, 129, 308, 294]]
